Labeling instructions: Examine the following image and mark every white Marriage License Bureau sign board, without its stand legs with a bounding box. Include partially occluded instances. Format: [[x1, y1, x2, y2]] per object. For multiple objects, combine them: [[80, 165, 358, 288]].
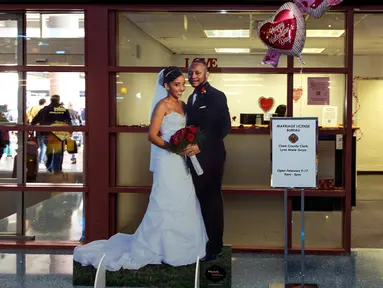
[[271, 117, 318, 188]]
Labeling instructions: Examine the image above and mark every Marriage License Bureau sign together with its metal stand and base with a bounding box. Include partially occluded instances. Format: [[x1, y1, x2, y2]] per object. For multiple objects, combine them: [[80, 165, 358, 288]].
[[269, 117, 319, 288]]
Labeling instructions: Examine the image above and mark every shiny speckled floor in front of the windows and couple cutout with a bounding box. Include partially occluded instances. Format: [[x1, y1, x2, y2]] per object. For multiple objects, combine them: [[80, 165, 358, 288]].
[[0, 250, 383, 288]]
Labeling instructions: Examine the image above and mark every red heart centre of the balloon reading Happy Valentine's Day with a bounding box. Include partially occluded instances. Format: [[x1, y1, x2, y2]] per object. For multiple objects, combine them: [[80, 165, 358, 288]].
[[259, 9, 297, 50]]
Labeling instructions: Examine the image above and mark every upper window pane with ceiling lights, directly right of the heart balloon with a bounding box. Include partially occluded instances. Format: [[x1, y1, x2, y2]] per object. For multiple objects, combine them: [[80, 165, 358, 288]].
[[294, 12, 346, 68]]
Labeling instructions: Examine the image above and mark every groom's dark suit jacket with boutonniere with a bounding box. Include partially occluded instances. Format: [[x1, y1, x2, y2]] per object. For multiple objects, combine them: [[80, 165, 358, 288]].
[[186, 82, 231, 171]]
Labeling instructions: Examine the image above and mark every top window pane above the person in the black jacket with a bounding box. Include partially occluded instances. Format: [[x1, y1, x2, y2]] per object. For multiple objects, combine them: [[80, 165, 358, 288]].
[[26, 13, 84, 66]]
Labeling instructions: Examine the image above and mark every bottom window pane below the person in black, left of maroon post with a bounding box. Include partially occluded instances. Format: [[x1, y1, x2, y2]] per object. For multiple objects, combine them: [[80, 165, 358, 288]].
[[24, 192, 84, 241]]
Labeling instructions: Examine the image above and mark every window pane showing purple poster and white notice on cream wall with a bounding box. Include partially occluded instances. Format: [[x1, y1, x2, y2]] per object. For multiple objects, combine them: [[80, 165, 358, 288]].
[[293, 74, 346, 127]]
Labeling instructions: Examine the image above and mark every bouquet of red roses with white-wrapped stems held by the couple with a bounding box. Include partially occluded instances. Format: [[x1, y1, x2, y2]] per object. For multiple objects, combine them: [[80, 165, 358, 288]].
[[169, 126, 203, 175]]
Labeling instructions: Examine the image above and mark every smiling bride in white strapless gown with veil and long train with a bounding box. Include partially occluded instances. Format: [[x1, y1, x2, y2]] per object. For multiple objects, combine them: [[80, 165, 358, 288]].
[[73, 67, 208, 271]]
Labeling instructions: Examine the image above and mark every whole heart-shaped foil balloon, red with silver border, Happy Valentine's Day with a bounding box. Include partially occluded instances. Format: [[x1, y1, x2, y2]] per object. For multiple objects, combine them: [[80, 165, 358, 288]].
[[258, 2, 306, 58]]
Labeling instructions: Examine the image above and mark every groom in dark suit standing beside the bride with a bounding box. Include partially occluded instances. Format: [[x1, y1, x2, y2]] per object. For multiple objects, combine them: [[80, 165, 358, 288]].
[[184, 60, 231, 261]]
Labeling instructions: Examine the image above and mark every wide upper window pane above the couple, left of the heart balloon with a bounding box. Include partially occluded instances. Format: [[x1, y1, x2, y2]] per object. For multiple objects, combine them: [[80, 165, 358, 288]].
[[116, 11, 287, 67]]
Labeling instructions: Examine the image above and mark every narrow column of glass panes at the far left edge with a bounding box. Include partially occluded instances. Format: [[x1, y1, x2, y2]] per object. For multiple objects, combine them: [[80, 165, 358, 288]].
[[0, 13, 34, 240]]
